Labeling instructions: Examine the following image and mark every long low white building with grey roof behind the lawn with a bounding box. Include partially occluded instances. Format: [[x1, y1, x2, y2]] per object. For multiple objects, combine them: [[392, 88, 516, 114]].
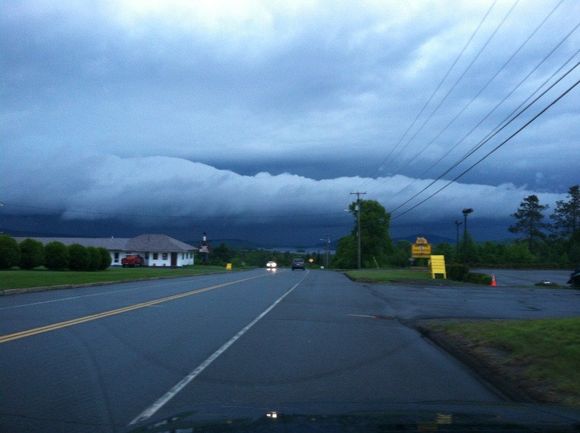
[[15, 234, 197, 268]]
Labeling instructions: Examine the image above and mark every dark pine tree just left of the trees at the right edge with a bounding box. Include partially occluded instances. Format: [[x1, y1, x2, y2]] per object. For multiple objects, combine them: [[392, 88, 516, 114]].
[[509, 194, 548, 252]]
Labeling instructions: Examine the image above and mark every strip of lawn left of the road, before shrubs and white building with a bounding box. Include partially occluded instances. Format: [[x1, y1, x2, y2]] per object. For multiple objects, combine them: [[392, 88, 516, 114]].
[[0, 265, 236, 290]]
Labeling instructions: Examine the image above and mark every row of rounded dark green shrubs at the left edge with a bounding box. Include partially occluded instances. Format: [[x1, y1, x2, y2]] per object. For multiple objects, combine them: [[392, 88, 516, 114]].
[[0, 236, 111, 271]]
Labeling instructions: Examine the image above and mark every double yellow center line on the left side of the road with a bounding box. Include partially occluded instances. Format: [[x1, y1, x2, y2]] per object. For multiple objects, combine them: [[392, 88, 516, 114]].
[[0, 274, 267, 344]]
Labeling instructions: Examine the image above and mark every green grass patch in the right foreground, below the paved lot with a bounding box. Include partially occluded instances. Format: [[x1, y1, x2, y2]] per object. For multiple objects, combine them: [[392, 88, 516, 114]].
[[436, 318, 580, 405]]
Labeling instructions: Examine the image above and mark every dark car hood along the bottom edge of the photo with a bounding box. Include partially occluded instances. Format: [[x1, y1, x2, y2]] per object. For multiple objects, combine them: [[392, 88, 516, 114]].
[[129, 402, 580, 433]]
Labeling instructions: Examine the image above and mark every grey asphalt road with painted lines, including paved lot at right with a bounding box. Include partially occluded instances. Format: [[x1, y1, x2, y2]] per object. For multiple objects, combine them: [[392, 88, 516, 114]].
[[0, 270, 580, 432]]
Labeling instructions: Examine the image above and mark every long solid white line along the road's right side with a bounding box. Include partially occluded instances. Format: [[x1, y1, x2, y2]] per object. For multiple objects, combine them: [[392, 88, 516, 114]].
[[129, 271, 310, 425]]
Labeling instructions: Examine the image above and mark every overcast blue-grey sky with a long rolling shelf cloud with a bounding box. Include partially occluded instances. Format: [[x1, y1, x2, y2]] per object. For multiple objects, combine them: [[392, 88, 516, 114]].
[[0, 0, 580, 242]]
